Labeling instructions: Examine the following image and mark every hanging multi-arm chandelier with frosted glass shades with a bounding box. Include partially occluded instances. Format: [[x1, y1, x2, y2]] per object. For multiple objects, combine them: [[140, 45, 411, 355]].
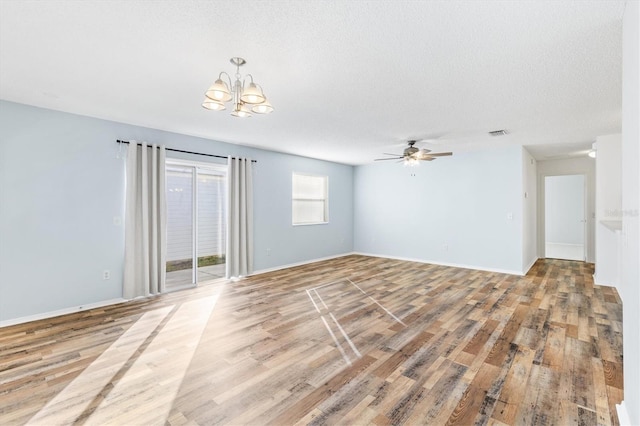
[[202, 58, 273, 117]]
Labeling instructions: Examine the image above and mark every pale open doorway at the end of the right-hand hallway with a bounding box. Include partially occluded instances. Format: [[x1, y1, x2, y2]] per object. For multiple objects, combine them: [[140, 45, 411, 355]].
[[544, 175, 586, 261]]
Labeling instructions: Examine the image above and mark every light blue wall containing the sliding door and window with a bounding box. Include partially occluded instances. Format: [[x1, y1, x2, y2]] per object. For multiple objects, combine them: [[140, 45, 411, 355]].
[[0, 101, 353, 321]]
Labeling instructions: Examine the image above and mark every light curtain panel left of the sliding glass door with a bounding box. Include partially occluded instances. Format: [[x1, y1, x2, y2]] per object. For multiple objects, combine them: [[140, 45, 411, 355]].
[[123, 141, 167, 299]]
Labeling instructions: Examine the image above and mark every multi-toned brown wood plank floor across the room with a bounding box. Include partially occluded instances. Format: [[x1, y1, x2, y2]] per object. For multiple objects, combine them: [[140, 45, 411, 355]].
[[0, 255, 623, 425]]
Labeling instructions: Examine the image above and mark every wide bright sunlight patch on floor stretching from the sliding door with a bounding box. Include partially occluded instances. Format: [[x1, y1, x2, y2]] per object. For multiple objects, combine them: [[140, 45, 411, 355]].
[[28, 286, 223, 425]]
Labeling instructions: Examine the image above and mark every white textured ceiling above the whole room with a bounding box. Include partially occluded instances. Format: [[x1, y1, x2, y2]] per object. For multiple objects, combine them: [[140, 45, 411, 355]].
[[0, 0, 625, 164]]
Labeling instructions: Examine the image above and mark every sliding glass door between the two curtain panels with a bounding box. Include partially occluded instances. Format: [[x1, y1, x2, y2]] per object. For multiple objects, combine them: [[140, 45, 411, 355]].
[[166, 162, 227, 291]]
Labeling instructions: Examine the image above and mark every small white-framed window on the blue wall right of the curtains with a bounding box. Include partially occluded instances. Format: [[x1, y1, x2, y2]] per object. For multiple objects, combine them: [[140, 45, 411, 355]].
[[292, 172, 329, 225]]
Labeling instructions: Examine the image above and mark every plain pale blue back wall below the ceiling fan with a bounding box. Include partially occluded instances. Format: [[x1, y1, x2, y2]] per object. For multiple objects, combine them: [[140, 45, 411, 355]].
[[354, 146, 523, 273]]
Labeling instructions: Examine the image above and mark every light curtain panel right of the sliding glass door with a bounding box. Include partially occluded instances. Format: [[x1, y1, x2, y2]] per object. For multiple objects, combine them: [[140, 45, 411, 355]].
[[226, 157, 253, 278]]
